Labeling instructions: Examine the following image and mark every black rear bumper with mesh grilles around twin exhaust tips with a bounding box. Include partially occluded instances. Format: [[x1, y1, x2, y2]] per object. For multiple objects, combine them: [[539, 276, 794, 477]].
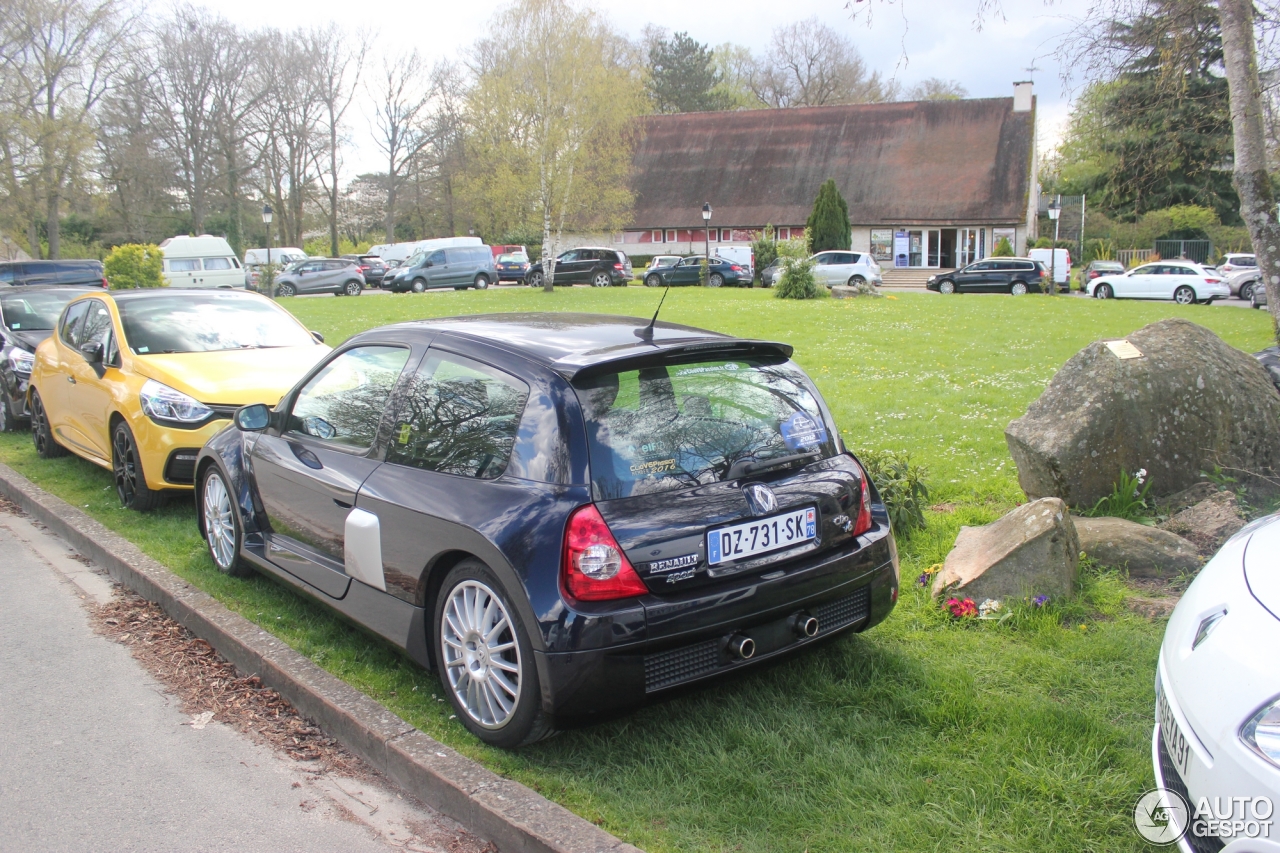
[[535, 526, 899, 720]]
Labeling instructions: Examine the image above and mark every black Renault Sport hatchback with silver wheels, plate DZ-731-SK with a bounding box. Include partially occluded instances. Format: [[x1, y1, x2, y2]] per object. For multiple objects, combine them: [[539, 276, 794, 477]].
[[197, 314, 899, 747]]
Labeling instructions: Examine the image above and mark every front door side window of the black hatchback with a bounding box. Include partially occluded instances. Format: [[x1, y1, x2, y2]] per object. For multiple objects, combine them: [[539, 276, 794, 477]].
[[285, 346, 410, 450]]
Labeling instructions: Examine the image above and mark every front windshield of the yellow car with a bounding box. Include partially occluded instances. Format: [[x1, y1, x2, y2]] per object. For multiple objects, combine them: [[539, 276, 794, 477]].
[[116, 291, 315, 355]]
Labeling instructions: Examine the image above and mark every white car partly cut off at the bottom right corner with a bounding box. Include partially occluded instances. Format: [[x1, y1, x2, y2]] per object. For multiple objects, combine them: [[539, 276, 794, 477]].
[[1151, 514, 1280, 853]]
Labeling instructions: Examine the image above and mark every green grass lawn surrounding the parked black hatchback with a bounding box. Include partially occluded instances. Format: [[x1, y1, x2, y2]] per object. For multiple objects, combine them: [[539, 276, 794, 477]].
[[0, 288, 1270, 853]]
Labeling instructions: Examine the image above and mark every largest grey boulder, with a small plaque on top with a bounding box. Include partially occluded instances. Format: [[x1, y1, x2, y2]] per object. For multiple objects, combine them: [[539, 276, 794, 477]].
[[1005, 319, 1280, 507]]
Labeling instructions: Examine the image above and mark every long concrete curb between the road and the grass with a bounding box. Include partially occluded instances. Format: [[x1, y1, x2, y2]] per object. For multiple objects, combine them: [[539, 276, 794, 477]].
[[0, 465, 640, 853]]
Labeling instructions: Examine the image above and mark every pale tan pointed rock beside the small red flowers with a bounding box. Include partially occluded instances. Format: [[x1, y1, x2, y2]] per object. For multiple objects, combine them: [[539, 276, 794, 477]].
[[933, 498, 1080, 602]]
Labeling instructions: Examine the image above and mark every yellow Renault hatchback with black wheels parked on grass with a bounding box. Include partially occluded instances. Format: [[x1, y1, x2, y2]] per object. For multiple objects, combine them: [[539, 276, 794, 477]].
[[27, 289, 329, 510]]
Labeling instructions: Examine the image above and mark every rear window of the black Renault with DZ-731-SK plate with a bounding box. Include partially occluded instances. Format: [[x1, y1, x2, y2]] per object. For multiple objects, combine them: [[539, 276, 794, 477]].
[[575, 360, 837, 501]]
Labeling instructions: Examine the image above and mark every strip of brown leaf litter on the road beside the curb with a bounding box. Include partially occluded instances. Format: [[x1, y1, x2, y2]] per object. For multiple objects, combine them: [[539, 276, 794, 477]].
[[92, 593, 370, 777]]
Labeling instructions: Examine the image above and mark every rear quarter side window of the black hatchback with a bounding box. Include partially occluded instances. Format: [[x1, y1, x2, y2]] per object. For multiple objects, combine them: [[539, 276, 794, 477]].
[[387, 352, 529, 480]]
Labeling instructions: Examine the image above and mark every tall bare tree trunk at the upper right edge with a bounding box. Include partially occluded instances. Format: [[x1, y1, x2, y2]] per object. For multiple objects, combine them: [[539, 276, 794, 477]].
[[1219, 0, 1280, 342]]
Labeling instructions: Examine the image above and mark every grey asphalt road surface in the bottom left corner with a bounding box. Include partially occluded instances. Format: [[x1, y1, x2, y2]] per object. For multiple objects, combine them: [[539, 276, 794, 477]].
[[0, 510, 486, 853]]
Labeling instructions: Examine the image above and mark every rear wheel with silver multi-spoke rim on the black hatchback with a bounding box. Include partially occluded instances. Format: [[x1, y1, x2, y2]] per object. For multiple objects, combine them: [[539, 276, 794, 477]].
[[431, 560, 553, 749]]
